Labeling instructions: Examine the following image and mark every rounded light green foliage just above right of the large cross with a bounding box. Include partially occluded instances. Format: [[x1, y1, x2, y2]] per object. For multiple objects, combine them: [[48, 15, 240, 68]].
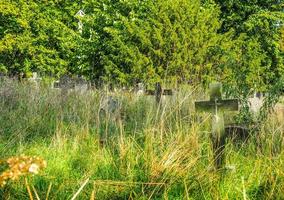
[[210, 33, 271, 94]]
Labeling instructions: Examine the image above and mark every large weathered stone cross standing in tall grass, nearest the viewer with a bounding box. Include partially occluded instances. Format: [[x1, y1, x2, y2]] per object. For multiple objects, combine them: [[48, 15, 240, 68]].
[[195, 83, 239, 169]]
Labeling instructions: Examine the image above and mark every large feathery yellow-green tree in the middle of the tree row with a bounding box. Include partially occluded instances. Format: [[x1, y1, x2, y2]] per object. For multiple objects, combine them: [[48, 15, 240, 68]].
[[81, 0, 220, 83]]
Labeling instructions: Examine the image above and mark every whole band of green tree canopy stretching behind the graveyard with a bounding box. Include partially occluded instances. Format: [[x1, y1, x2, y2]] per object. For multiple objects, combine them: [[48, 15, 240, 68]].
[[0, 0, 284, 90]]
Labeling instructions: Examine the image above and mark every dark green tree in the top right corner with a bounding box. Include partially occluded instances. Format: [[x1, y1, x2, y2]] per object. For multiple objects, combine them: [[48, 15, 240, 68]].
[[215, 0, 284, 90]]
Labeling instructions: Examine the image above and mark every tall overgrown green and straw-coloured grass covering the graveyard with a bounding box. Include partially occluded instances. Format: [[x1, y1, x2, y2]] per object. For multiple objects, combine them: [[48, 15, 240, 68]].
[[0, 81, 284, 199]]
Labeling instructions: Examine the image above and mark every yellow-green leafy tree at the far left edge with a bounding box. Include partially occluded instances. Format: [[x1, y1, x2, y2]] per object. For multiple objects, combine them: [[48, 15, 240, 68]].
[[0, 0, 81, 75]]
